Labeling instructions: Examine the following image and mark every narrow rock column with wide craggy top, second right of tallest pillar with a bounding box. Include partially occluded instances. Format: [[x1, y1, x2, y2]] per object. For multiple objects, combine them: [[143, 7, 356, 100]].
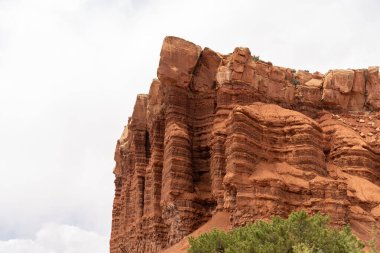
[[209, 47, 258, 210]]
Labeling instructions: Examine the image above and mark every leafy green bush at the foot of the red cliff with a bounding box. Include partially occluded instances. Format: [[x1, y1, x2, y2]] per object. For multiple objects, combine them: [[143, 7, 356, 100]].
[[189, 211, 364, 253]]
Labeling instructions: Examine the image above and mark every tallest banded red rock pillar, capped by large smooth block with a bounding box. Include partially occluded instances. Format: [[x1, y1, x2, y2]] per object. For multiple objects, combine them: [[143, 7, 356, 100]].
[[157, 37, 201, 245]]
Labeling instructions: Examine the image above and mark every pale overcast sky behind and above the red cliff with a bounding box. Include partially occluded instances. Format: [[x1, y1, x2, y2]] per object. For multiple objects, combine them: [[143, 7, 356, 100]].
[[0, 0, 380, 253]]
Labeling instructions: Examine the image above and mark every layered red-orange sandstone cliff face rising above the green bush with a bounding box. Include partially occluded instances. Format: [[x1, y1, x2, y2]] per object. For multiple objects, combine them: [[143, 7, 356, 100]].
[[110, 37, 380, 253]]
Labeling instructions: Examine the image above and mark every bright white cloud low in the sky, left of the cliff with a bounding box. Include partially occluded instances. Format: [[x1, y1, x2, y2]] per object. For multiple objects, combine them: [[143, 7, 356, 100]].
[[0, 223, 108, 253]]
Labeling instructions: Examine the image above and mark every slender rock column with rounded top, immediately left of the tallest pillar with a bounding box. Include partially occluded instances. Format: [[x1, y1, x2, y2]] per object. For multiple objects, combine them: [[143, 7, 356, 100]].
[[142, 79, 167, 252]]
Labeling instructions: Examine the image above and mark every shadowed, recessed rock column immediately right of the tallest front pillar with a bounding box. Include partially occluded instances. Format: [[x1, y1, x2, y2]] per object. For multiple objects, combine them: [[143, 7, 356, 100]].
[[188, 48, 222, 221]]
